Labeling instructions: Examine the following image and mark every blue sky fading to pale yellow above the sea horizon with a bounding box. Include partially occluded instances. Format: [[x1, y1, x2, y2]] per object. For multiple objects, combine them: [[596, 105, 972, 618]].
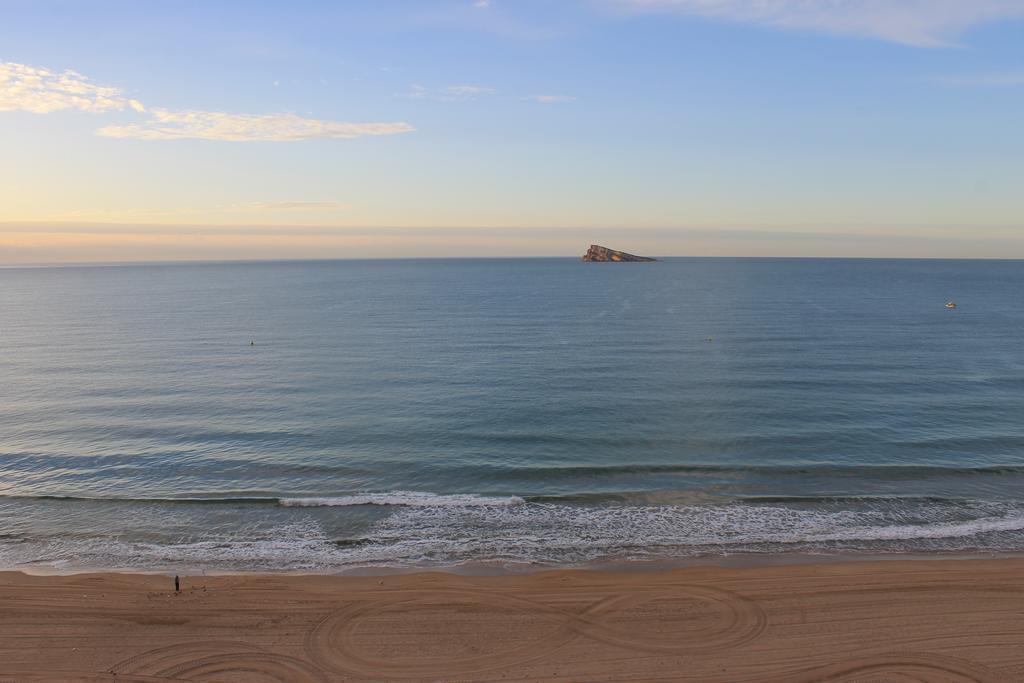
[[0, 0, 1024, 264]]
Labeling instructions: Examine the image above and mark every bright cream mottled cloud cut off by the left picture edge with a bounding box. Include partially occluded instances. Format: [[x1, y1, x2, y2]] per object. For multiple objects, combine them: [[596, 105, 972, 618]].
[[0, 61, 145, 114]]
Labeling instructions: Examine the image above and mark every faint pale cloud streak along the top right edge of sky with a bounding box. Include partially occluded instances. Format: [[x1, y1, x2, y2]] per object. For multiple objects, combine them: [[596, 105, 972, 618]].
[[612, 0, 1024, 47]]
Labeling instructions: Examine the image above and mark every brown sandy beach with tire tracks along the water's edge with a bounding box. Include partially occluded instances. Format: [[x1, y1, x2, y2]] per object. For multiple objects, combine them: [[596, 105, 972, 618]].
[[0, 559, 1024, 682]]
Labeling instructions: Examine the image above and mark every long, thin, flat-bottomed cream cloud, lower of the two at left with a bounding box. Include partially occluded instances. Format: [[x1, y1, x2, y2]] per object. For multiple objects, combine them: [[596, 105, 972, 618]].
[[96, 110, 415, 142]]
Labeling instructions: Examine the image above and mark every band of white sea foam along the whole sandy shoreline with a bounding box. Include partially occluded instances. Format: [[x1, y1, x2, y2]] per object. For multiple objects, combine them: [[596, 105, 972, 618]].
[[6, 499, 1024, 571]]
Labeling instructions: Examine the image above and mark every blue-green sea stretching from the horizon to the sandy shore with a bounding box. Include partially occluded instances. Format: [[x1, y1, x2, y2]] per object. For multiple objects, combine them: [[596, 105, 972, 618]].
[[0, 259, 1024, 571]]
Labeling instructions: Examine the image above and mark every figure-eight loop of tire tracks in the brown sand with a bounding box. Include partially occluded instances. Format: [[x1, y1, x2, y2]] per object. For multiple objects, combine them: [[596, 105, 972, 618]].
[[306, 585, 767, 678]]
